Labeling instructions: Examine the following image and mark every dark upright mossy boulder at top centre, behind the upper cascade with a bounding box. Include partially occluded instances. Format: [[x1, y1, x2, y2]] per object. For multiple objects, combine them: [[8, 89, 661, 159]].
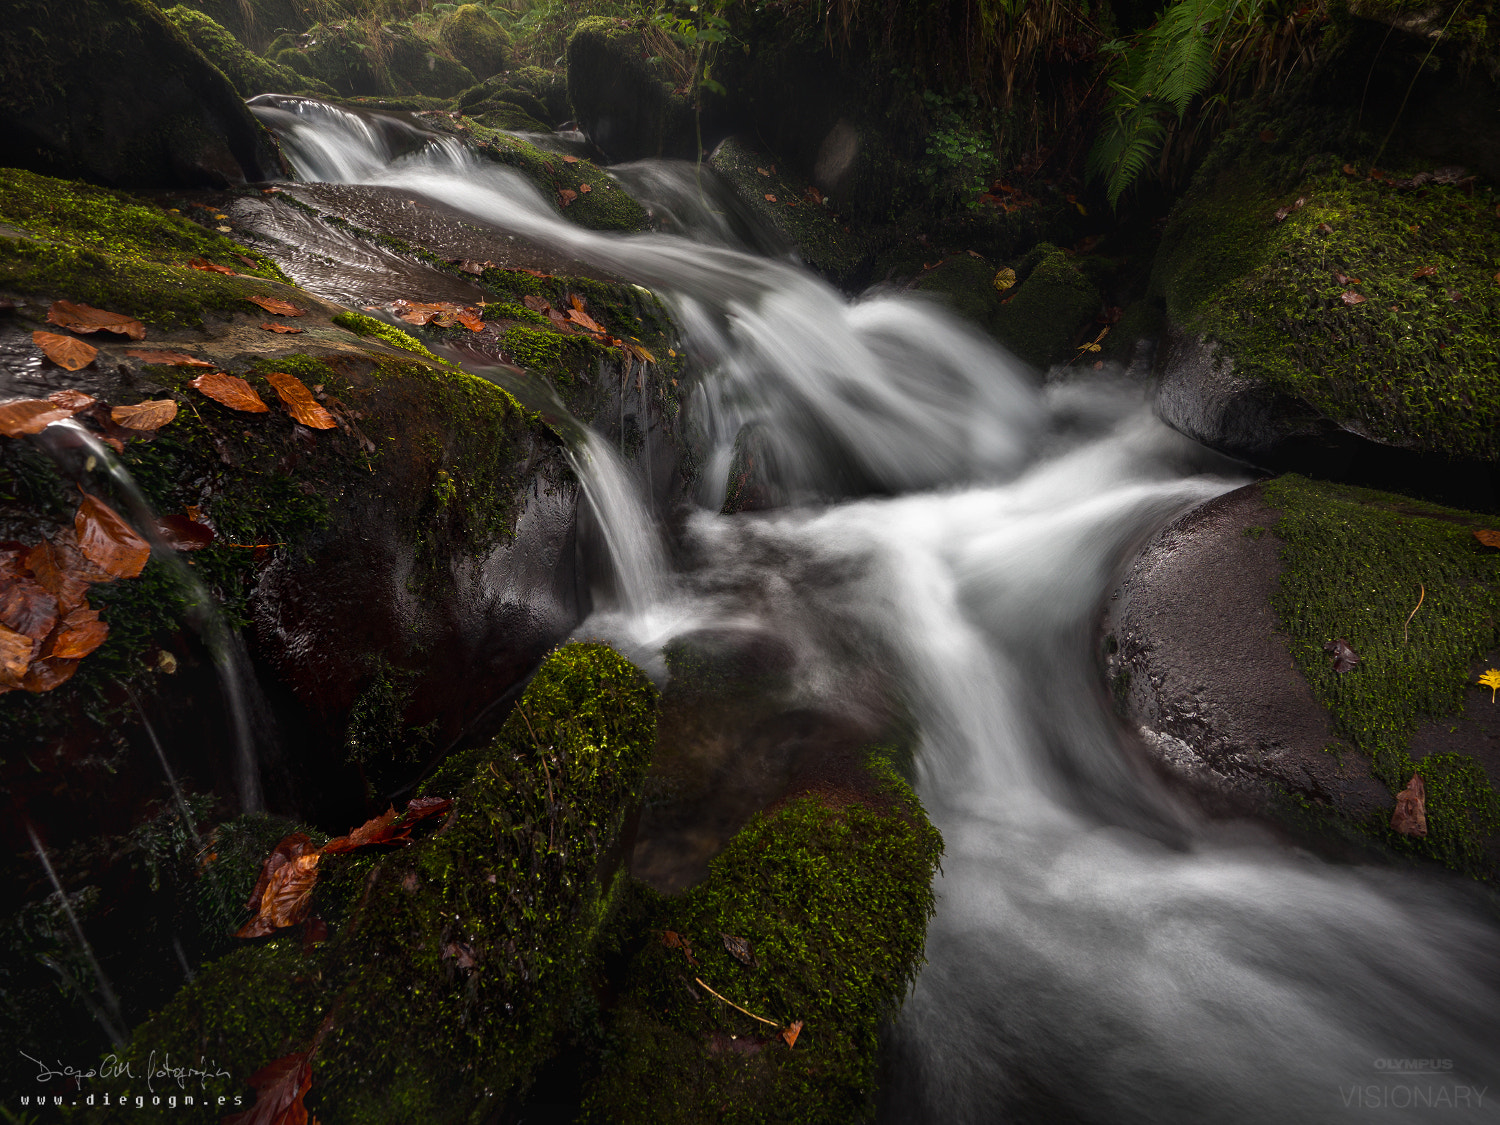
[[567, 17, 698, 161]]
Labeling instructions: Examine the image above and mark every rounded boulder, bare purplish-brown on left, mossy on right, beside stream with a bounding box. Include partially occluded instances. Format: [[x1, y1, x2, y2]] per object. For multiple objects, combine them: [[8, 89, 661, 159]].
[[1106, 476, 1500, 879]]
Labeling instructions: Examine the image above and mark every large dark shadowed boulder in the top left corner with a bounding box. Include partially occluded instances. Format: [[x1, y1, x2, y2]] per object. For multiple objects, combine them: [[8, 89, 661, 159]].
[[0, 0, 281, 188]]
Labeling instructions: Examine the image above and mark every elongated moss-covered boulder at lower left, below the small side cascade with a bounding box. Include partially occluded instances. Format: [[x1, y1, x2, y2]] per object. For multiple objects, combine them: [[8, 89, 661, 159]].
[[95, 645, 656, 1125]]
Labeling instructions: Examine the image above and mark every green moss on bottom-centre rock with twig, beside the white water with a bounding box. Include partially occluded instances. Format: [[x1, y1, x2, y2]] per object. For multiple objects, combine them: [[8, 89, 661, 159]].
[[584, 761, 942, 1125]]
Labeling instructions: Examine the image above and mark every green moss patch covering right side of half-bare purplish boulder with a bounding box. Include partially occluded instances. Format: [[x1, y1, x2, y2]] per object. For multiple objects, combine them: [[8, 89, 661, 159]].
[[1265, 476, 1500, 872]]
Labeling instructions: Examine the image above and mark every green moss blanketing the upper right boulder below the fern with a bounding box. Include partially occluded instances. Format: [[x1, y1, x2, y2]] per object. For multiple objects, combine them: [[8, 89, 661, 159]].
[[1154, 152, 1500, 458]]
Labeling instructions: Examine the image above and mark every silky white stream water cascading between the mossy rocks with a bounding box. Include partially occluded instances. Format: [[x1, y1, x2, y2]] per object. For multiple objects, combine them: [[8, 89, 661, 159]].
[[249, 99, 1500, 1124]]
